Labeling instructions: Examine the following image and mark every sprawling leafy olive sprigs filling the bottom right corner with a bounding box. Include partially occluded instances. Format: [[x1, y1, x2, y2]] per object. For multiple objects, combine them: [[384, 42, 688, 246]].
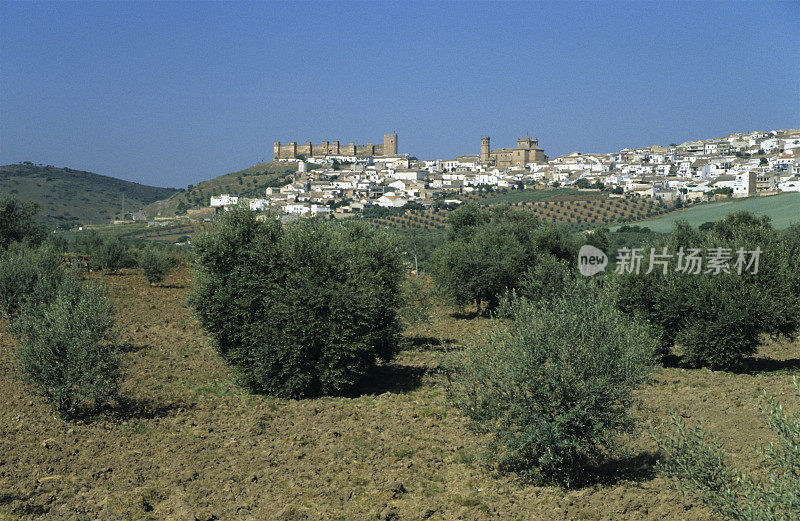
[[657, 378, 800, 521]]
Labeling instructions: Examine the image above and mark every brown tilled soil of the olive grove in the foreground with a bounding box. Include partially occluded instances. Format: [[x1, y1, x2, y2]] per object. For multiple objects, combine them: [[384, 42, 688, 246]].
[[0, 270, 800, 521]]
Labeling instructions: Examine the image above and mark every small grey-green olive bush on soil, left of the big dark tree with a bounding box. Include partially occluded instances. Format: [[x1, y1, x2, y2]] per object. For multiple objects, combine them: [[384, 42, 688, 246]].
[[12, 277, 120, 418]]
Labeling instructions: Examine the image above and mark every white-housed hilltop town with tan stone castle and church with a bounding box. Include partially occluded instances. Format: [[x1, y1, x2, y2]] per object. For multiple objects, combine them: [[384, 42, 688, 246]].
[[209, 130, 800, 216]]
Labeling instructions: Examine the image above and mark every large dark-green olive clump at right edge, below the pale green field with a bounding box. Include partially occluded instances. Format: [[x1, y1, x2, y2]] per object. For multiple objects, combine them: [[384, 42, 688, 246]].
[[615, 212, 800, 370]]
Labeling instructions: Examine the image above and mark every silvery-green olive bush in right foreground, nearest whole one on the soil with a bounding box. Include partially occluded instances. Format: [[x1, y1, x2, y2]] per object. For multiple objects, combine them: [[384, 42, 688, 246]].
[[444, 279, 655, 486]]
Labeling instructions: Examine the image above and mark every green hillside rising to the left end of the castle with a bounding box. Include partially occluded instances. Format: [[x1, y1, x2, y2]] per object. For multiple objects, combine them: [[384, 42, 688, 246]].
[[145, 161, 297, 217]]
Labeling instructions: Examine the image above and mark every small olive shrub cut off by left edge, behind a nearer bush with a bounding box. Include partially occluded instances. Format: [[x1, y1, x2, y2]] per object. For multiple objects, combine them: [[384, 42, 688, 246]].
[[0, 243, 64, 316]]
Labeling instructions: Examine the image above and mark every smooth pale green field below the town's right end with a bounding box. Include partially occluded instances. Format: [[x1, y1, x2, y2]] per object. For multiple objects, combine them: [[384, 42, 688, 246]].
[[612, 193, 800, 233]]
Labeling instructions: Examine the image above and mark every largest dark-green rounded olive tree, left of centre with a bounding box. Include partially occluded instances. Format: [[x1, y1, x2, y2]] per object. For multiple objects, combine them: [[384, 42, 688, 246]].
[[191, 208, 403, 398]]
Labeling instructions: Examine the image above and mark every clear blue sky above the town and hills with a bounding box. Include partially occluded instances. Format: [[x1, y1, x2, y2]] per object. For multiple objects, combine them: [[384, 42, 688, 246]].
[[0, 0, 800, 187]]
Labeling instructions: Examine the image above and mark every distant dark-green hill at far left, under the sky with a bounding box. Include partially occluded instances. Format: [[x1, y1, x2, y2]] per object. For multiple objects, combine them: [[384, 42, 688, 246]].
[[0, 164, 179, 227]]
